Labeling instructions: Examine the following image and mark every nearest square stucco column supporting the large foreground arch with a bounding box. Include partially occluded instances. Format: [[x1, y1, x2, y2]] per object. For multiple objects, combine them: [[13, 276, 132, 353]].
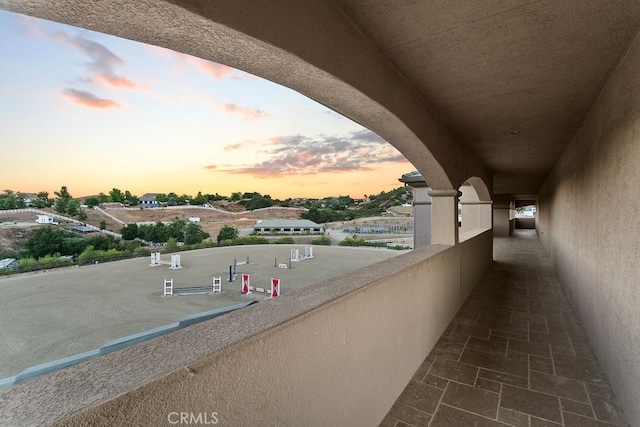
[[428, 189, 462, 246]]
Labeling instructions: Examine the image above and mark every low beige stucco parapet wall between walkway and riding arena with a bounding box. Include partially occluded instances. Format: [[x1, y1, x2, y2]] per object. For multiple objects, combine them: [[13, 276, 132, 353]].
[[0, 230, 493, 426]]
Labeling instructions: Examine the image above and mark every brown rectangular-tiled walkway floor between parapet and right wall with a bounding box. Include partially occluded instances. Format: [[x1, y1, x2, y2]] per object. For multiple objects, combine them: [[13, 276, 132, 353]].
[[380, 230, 627, 427]]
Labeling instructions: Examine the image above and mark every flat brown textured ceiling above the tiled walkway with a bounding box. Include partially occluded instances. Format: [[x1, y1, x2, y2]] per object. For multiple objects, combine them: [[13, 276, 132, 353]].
[[336, 0, 640, 193]]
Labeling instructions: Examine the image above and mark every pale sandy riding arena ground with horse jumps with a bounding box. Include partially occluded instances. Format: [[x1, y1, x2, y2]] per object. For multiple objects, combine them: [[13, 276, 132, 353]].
[[0, 245, 406, 378]]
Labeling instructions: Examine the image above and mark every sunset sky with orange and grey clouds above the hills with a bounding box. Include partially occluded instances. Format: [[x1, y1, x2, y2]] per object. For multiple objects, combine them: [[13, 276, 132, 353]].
[[0, 10, 415, 199]]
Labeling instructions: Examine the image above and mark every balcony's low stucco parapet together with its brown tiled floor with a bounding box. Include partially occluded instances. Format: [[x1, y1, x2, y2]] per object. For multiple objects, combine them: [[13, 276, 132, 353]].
[[0, 230, 626, 426]]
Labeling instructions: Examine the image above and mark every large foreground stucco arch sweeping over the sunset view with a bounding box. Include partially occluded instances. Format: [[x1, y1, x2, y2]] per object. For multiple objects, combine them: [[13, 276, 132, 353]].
[[0, 0, 490, 189]]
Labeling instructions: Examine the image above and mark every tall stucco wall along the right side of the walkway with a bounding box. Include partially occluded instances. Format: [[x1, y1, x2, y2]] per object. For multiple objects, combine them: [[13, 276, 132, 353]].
[[538, 30, 640, 425]]
